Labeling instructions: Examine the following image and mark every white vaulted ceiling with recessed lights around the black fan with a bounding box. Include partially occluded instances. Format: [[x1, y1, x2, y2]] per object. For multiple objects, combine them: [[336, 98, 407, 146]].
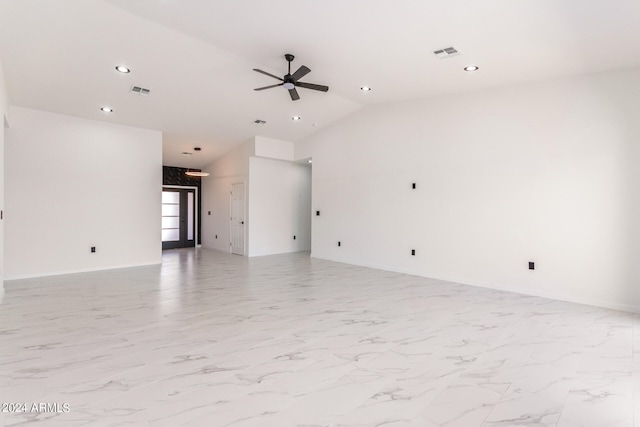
[[0, 0, 640, 167]]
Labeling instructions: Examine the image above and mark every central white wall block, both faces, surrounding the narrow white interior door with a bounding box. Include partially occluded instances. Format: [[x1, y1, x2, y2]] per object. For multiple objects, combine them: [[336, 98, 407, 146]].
[[202, 136, 311, 256]]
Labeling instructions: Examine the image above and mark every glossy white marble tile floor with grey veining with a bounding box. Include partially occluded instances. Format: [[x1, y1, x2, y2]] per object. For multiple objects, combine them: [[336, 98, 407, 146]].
[[0, 249, 640, 427]]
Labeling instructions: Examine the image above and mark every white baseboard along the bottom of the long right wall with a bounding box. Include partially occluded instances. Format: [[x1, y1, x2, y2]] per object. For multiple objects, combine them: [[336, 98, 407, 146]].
[[311, 253, 640, 313]]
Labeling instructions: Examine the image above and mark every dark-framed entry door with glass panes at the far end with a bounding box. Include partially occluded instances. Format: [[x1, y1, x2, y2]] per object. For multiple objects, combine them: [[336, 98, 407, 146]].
[[162, 187, 197, 250]]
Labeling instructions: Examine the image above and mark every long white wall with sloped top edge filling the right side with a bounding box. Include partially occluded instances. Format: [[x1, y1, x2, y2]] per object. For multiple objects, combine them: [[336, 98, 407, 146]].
[[296, 69, 640, 310]]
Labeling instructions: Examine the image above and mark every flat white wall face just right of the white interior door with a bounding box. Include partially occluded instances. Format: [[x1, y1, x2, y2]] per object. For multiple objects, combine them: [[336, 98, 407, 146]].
[[249, 157, 311, 256]]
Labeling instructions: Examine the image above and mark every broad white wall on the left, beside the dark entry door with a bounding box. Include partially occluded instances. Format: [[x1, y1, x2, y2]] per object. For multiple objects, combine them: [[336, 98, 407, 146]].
[[5, 107, 162, 279]]
